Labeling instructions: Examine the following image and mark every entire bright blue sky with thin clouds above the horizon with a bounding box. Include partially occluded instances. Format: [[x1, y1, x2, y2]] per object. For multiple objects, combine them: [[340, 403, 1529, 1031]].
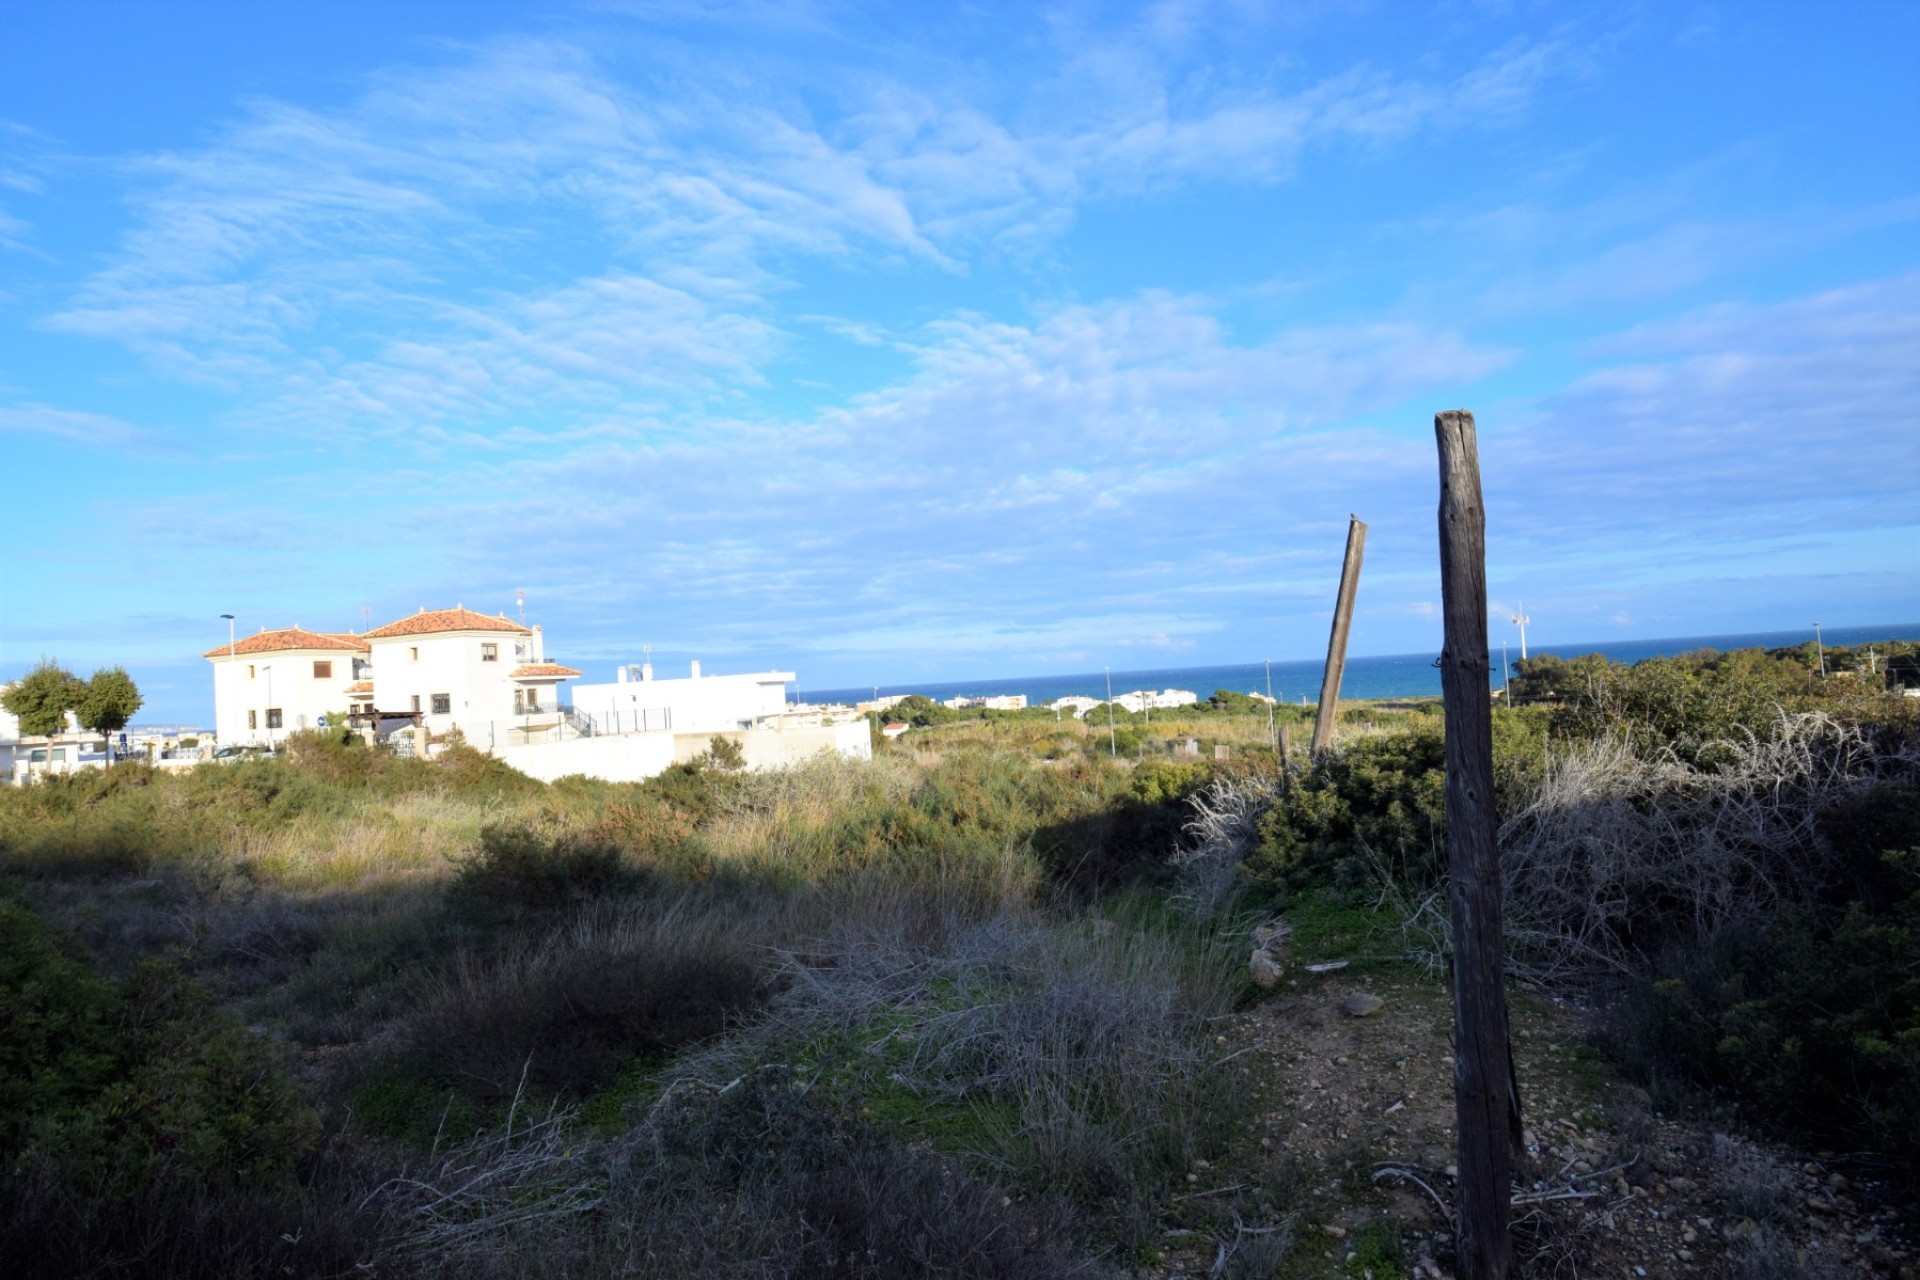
[[0, 0, 1920, 720]]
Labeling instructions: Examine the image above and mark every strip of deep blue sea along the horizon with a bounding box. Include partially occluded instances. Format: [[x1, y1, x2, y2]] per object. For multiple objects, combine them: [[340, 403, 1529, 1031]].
[[791, 622, 1920, 704]]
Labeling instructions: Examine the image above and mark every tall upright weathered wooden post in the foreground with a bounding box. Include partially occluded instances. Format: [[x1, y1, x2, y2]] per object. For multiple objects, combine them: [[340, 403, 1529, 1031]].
[[1434, 409, 1521, 1280]]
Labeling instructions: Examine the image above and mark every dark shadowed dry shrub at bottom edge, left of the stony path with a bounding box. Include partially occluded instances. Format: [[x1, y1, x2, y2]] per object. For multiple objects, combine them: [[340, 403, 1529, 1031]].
[[386, 1067, 1102, 1280]]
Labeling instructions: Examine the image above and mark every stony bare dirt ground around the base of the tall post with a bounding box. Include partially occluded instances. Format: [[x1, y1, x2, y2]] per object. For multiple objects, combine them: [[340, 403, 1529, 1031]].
[[1156, 917, 1920, 1280]]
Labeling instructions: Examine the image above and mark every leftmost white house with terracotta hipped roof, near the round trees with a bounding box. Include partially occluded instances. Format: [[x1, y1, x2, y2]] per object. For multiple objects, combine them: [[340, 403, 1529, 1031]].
[[202, 626, 369, 747]]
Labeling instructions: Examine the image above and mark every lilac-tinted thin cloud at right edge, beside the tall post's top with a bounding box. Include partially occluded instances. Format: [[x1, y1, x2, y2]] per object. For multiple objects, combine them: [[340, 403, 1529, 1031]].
[[1490, 274, 1920, 557]]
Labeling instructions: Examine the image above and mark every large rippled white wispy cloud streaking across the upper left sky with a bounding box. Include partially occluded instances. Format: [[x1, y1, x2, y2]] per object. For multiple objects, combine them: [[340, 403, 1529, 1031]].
[[45, 23, 1561, 430]]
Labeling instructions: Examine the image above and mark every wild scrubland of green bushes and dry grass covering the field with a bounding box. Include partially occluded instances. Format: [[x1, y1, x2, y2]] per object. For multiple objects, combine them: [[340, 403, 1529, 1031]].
[[0, 651, 1920, 1278]]
